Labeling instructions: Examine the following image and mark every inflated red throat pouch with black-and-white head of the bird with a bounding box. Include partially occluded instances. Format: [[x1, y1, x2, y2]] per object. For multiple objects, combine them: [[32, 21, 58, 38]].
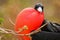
[[15, 4, 44, 40]]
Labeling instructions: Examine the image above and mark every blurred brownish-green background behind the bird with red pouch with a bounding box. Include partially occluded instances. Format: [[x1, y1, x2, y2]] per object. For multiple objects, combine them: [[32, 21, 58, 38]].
[[0, 0, 60, 40]]
